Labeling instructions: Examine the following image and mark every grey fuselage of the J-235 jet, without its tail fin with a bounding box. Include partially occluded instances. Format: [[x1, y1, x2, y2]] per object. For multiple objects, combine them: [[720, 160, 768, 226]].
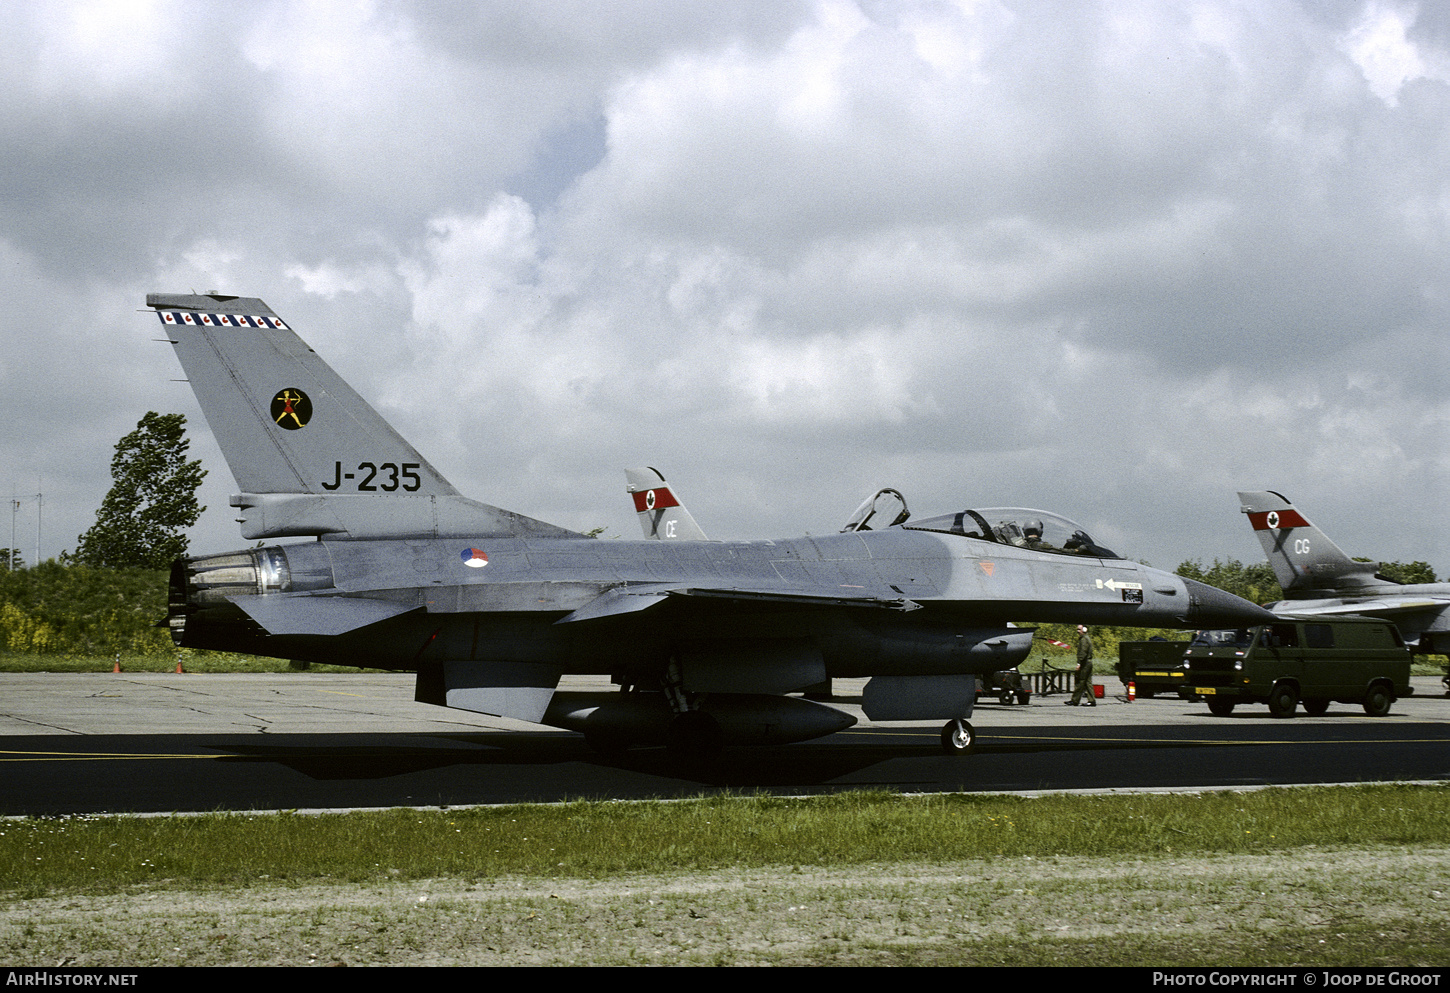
[[173, 528, 1263, 676]]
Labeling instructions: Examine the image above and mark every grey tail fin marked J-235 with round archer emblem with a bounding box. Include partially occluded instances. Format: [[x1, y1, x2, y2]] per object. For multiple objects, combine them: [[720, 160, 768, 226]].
[[146, 293, 574, 538]]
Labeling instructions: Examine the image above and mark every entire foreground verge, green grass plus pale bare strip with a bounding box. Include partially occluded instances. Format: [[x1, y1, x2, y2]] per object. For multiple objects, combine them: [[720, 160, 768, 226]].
[[0, 786, 1450, 965]]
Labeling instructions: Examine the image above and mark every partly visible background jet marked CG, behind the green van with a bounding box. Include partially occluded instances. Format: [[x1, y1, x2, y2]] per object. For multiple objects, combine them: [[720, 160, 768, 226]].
[[1238, 490, 1450, 655]]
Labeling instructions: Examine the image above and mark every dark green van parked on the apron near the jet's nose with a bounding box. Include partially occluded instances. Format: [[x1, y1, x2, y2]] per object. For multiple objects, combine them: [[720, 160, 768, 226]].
[[1179, 618, 1414, 718]]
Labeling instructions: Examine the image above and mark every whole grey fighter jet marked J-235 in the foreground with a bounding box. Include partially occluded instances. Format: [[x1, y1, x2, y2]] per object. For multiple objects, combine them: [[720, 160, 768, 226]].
[[146, 294, 1272, 752]]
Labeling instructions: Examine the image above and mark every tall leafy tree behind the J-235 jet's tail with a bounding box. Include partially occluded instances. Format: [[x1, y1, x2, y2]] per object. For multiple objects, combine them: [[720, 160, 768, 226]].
[[74, 410, 206, 568]]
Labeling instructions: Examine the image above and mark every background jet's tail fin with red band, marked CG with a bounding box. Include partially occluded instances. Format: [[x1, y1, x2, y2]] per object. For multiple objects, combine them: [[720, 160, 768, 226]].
[[1238, 490, 1380, 597]]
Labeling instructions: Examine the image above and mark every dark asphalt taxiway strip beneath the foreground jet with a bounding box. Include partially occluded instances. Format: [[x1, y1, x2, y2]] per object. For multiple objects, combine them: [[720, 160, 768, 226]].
[[8, 719, 1450, 815]]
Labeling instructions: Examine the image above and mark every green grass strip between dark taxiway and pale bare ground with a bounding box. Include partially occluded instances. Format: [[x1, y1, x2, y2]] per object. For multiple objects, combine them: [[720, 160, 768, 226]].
[[0, 786, 1450, 899]]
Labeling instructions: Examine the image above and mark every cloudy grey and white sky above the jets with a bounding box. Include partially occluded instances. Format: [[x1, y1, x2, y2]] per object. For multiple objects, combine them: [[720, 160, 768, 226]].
[[0, 0, 1450, 576]]
